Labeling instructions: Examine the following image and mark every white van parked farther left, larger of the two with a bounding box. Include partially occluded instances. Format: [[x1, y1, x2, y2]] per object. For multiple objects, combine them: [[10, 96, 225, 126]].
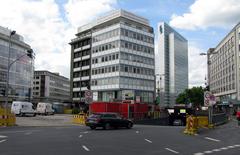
[[11, 101, 36, 116]]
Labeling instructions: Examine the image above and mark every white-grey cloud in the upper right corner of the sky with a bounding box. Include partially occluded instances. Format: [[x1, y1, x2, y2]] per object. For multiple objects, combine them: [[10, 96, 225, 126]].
[[170, 0, 240, 30]]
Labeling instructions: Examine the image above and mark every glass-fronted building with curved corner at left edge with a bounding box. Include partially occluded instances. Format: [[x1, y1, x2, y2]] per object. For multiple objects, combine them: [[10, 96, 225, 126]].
[[0, 26, 34, 103]]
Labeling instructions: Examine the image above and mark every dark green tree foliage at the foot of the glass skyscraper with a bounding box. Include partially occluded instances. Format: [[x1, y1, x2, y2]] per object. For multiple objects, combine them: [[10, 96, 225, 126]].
[[176, 87, 204, 107]]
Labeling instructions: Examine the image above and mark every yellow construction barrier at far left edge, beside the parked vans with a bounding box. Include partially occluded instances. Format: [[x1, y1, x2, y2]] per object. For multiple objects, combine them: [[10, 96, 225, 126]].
[[0, 108, 16, 126]]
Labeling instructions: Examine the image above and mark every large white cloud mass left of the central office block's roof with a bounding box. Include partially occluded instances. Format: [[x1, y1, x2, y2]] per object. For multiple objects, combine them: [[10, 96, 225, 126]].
[[0, 0, 115, 77]]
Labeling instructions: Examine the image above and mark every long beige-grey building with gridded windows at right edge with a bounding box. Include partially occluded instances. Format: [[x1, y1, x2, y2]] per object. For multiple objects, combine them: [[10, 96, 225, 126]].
[[207, 23, 240, 102]]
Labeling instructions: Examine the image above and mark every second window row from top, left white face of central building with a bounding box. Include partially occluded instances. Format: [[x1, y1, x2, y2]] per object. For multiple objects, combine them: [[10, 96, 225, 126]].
[[92, 40, 120, 53]]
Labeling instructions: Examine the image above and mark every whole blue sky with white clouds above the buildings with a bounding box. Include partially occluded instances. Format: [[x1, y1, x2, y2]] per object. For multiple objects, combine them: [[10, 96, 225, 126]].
[[0, 0, 240, 87]]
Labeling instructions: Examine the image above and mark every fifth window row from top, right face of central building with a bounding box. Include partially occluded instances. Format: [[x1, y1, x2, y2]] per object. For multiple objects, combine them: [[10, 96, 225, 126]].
[[120, 64, 154, 75]]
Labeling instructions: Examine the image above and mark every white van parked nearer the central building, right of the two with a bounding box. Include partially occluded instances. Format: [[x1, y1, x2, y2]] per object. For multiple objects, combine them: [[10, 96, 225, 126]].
[[37, 102, 54, 115]]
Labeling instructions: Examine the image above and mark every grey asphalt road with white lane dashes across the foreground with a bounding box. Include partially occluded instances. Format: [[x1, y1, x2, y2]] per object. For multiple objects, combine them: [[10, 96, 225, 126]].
[[0, 121, 240, 155]]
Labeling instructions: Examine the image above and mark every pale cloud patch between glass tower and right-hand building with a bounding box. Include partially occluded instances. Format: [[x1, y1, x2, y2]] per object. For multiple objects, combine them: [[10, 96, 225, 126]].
[[188, 43, 207, 88]]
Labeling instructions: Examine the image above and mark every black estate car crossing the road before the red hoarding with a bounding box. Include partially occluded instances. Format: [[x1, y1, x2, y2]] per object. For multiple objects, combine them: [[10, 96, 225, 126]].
[[86, 113, 133, 129]]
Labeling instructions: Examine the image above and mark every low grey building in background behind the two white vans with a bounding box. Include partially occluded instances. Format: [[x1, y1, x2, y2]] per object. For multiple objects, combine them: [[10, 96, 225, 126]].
[[33, 71, 70, 103]]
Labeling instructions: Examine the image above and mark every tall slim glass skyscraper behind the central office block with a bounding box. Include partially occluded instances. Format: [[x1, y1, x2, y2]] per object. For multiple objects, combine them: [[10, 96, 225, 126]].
[[156, 22, 188, 105]]
